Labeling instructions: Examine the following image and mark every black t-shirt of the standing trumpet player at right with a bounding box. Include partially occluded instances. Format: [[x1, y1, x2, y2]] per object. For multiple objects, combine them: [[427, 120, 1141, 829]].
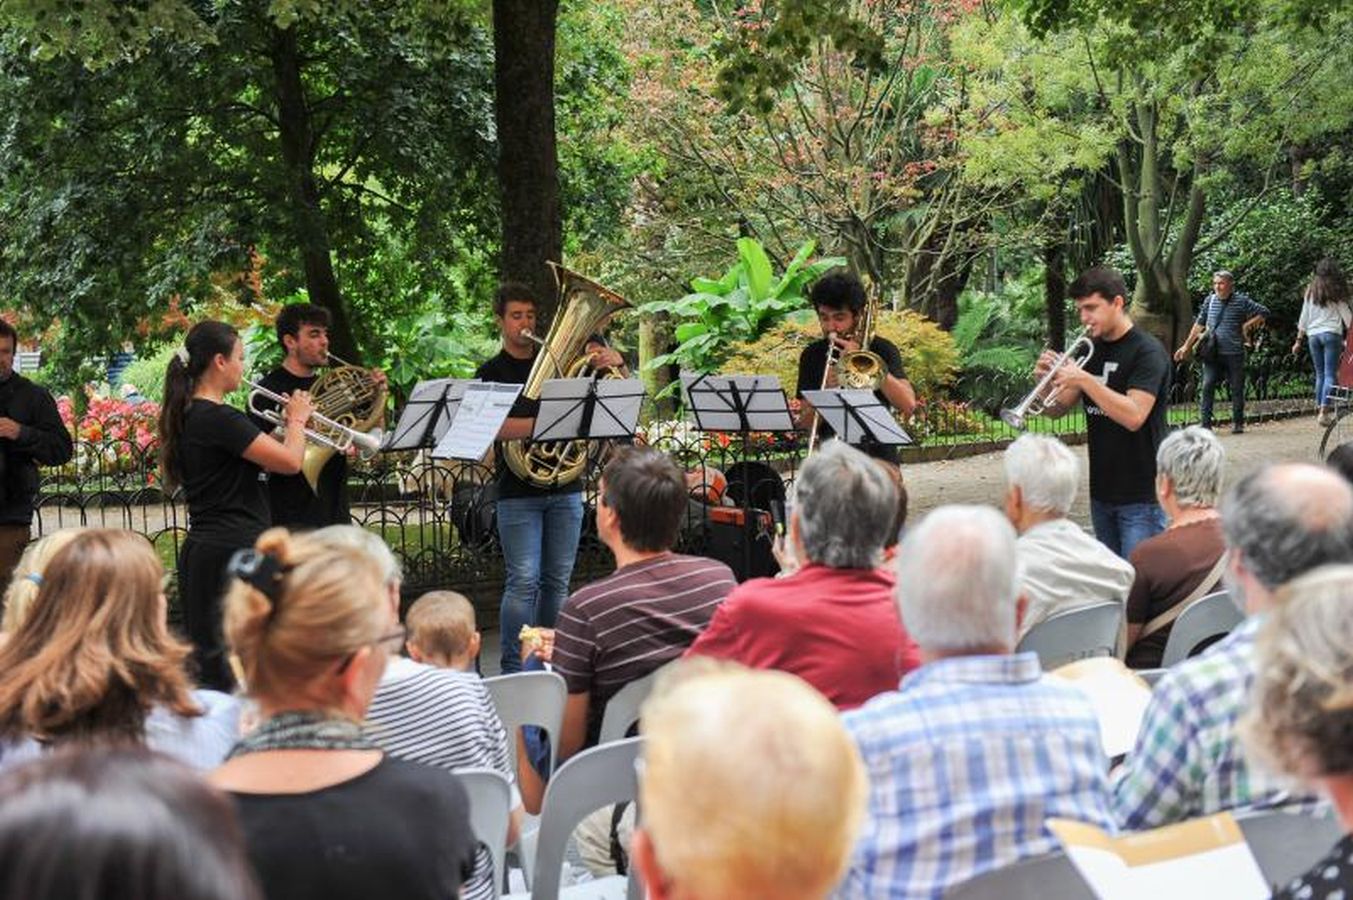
[[1082, 328, 1170, 503]]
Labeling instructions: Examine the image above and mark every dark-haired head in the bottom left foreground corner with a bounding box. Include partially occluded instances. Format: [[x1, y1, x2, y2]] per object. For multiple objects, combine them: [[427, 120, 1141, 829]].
[[0, 747, 260, 900]]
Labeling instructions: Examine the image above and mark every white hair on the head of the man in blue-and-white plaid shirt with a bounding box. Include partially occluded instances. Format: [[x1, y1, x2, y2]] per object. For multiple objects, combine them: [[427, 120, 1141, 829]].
[[897, 506, 1019, 652]]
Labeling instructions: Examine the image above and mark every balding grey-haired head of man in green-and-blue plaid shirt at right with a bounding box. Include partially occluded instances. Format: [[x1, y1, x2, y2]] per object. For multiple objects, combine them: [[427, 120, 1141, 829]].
[[1222, 463, 1353, 590]]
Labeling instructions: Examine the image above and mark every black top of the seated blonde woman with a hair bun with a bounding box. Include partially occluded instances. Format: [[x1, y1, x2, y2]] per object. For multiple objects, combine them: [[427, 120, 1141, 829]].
[[231, 757, 476, 900]]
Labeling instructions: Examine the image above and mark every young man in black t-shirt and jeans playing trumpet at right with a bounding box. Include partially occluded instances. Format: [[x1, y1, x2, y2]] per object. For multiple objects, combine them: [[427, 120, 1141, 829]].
[[1035, 267, 1170, 559]]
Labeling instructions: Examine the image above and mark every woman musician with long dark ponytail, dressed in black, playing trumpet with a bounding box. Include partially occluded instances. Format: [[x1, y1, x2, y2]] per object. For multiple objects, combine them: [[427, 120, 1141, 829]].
[[160, 321, 313, 690]]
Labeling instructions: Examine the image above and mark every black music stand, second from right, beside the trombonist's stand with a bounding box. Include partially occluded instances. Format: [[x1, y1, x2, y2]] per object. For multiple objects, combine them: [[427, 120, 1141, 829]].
[[681, 375, 794, 575]]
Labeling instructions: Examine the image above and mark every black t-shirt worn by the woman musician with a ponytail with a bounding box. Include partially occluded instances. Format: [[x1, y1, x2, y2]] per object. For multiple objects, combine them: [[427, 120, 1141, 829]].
[[180, 399, 271, 547]]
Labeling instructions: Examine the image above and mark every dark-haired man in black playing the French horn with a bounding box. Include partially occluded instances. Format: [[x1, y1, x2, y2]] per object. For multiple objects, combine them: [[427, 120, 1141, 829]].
[[249, 303, 386, 528]]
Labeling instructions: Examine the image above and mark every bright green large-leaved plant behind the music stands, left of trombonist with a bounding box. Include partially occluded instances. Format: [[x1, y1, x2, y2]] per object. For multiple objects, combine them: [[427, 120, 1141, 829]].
[[641, 238, 846, 372]]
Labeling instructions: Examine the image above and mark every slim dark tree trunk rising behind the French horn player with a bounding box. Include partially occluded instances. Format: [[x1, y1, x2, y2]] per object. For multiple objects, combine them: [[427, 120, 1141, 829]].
[[272, 27, 360, 363]]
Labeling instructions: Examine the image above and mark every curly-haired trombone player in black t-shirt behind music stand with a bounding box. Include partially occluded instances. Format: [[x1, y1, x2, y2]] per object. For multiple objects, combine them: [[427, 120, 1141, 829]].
[[797, 269, 916, 463]]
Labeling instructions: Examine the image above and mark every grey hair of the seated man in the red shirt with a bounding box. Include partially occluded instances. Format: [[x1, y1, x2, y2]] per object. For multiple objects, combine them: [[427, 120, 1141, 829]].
[[794, 440, 897, 568]]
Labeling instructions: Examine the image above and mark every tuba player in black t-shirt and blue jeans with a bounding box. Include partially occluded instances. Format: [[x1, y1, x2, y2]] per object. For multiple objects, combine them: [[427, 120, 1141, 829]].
[[475, 282, 624, 673]]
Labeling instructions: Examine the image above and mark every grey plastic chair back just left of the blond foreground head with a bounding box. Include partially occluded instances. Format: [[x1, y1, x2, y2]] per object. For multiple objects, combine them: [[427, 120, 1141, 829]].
[[530, 738, 643, 900]]
